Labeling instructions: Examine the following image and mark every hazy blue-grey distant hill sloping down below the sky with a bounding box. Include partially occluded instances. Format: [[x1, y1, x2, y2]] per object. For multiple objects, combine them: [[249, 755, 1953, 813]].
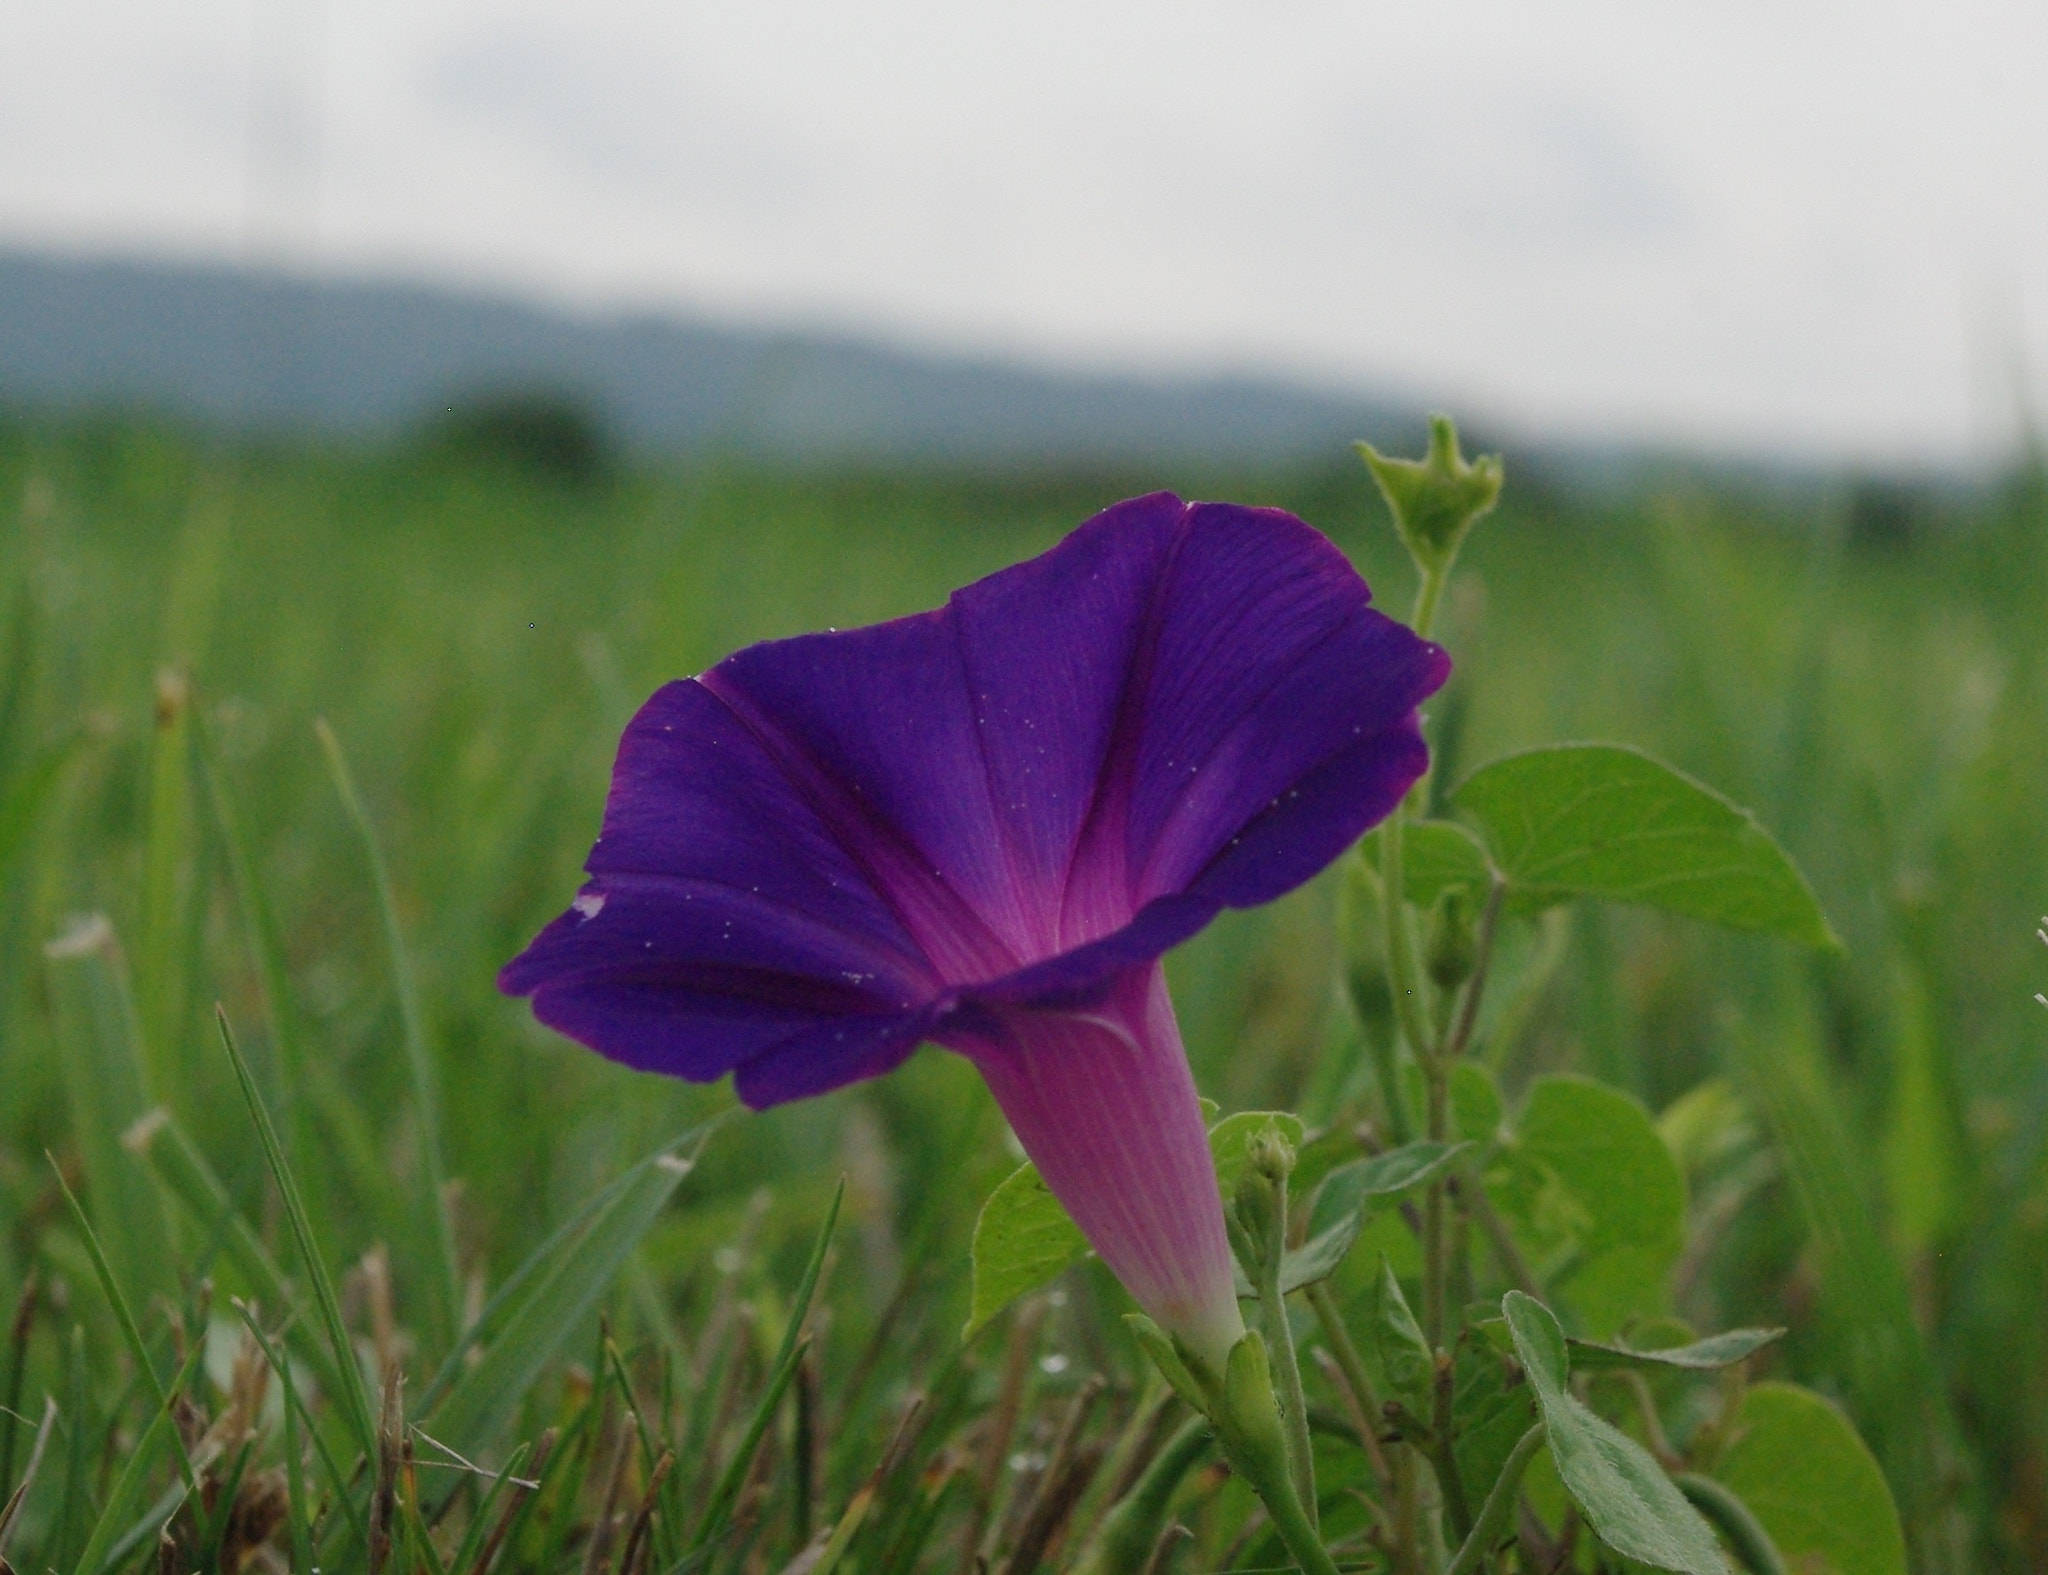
[[0, 250, 1421, 465]]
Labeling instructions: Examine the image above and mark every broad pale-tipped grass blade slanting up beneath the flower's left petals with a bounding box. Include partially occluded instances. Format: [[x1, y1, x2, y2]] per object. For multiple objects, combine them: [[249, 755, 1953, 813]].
[[420, 1129, 702, 1454]]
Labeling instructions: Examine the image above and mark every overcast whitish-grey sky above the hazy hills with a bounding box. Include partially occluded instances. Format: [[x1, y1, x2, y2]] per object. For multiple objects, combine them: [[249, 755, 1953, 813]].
[[0, 0, 2048, 461]]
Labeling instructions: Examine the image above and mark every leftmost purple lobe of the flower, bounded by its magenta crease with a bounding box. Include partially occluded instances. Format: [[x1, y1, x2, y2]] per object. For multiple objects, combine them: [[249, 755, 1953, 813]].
[[498, 680, 934, 1104]]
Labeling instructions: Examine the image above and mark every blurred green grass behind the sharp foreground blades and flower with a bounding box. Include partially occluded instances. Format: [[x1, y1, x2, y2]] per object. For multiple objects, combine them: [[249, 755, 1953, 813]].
[[0, 418, 2048, 1571]]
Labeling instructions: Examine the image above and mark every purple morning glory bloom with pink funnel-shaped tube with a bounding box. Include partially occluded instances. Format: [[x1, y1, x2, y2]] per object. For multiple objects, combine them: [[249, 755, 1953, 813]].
[[500, 494, 1450, 1360]]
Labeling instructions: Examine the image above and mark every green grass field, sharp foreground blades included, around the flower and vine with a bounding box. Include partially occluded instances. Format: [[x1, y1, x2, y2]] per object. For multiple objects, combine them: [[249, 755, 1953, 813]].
[[0, 420, 2048, 1575]]
